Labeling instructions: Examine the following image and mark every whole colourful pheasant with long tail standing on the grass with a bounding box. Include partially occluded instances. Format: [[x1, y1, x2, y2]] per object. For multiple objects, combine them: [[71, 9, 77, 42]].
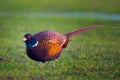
[[23, 25, 101, 67]]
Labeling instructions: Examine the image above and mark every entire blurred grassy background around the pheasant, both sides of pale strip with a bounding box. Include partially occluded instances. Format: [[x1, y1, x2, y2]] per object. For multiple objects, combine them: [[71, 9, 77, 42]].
[[0, 0, 120, 80]]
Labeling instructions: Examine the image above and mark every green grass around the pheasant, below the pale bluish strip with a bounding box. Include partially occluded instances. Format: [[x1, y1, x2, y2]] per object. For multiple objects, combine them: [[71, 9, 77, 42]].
[[0, 17, 120, 80]]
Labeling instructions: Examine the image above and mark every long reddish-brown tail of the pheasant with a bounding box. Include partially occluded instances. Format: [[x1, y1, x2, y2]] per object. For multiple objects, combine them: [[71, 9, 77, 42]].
[[65, 25, 102, 38]]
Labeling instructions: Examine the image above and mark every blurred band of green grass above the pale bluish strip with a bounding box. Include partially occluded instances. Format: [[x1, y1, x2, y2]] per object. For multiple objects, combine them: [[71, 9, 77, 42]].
[[0, 0, 120, 13]]
